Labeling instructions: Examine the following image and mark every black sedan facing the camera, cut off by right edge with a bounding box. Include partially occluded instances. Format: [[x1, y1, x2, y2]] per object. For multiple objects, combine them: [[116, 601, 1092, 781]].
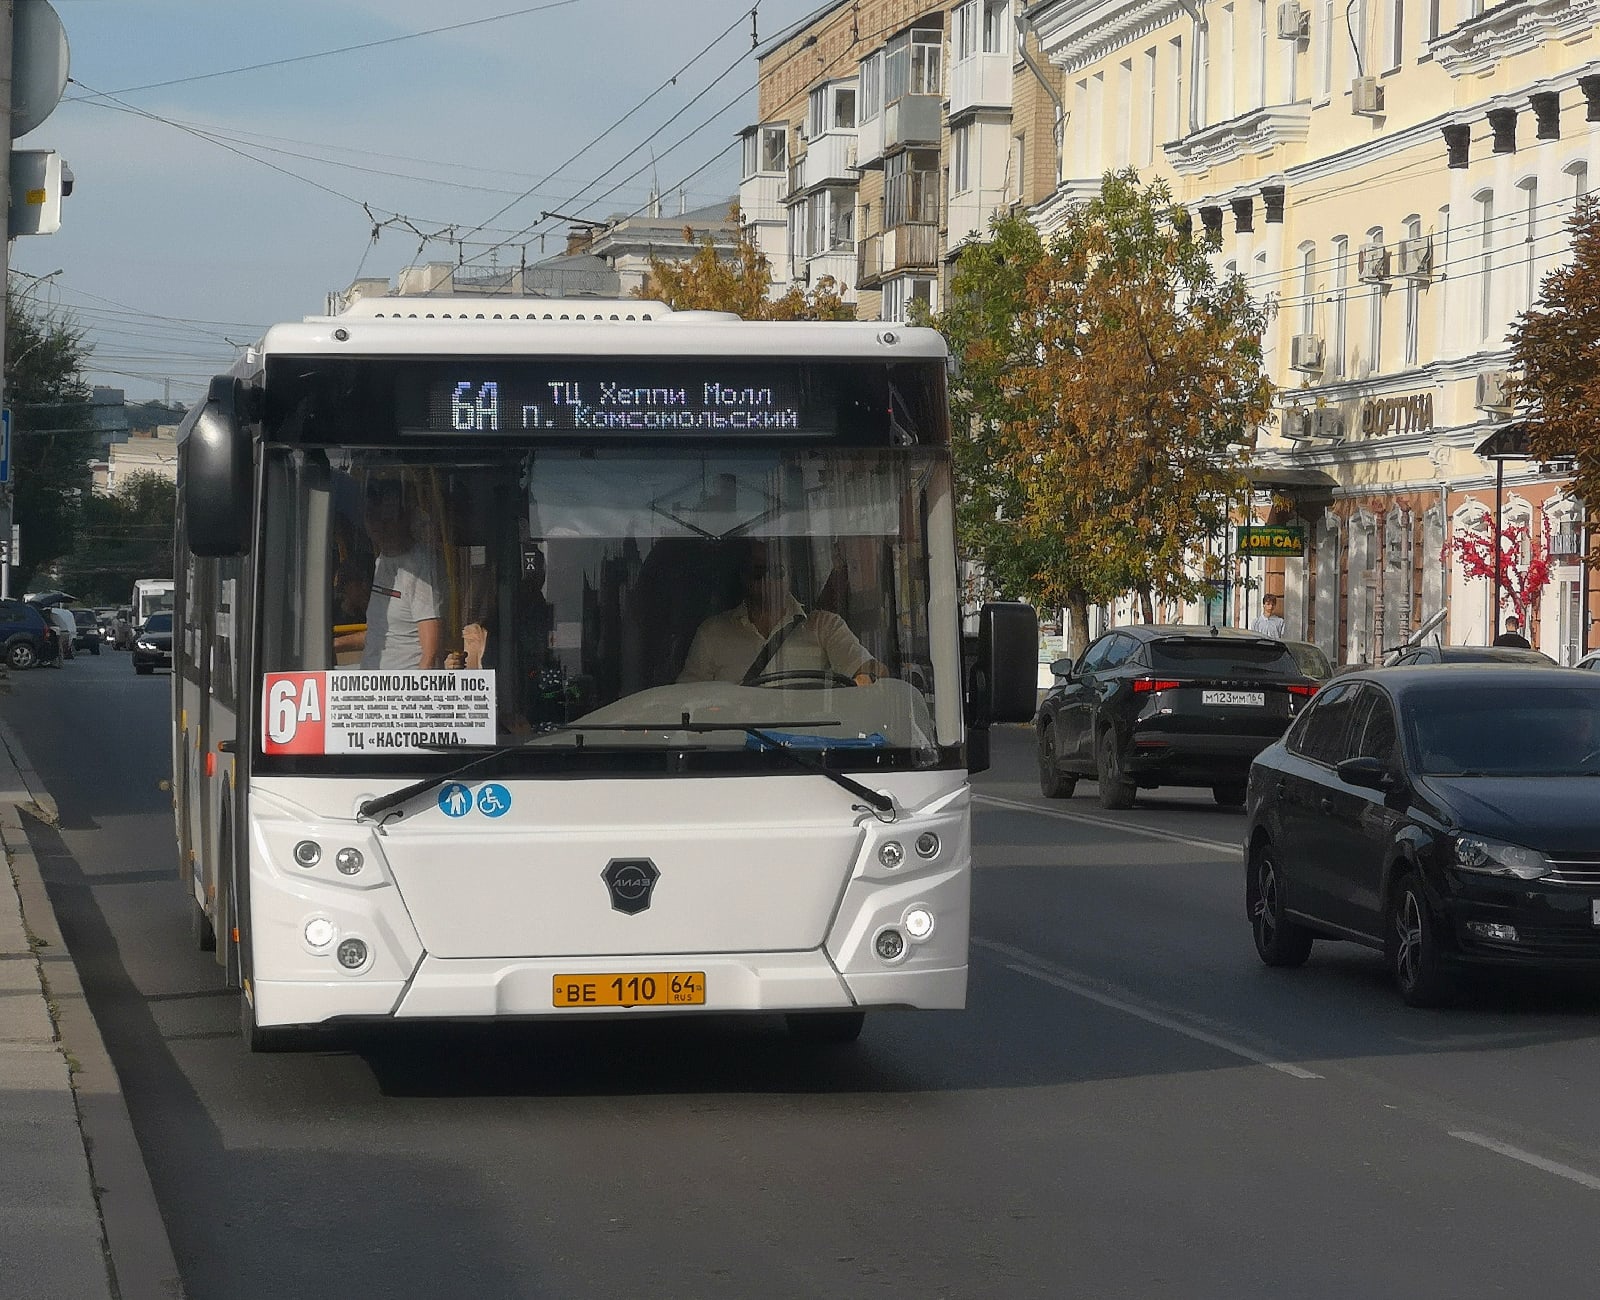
[[1245, 664, 1600, 1005]]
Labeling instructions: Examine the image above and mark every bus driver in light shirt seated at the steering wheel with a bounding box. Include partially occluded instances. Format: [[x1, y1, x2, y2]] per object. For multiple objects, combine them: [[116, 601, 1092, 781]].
[[678, 543, 888, 687]]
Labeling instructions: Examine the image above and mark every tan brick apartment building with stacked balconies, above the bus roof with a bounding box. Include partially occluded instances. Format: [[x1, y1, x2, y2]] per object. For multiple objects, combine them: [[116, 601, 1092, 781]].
[[739, 0, 1062, 320]]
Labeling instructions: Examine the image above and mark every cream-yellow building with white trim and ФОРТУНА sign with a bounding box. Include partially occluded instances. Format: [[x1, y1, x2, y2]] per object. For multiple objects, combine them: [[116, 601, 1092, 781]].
[[1027, 0, 1600, 661]]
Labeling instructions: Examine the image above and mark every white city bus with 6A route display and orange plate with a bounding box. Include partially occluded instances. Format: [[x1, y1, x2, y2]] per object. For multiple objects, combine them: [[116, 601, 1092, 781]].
[[173, 298, 1035, 1050]]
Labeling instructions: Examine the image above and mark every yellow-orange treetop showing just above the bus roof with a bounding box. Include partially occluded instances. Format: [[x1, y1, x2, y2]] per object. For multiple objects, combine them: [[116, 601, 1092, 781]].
[[638, 205, 856, 320]]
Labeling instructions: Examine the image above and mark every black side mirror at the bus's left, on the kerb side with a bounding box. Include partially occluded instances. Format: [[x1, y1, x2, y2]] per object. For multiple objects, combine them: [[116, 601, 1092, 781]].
[[179, 375, 254, 557]]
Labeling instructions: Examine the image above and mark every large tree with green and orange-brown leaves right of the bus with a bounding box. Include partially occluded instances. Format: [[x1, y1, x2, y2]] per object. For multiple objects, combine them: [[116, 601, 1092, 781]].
[[934, 170, 1272, 653]]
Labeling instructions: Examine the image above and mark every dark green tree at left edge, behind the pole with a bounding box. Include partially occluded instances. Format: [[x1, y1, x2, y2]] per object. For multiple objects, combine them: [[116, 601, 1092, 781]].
[[5, 293, 96, 592]]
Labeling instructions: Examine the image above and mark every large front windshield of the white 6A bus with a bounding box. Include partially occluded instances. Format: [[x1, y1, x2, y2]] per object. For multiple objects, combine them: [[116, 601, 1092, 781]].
[[259, 445, 962, 770]]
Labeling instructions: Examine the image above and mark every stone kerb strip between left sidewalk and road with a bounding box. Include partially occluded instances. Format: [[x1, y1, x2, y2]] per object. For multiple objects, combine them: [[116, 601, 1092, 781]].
[[0, 722, 184, 1300]]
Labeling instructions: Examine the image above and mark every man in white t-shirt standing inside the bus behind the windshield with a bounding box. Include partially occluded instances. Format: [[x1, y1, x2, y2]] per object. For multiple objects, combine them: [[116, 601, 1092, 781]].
[[362, 479, 442, 668]]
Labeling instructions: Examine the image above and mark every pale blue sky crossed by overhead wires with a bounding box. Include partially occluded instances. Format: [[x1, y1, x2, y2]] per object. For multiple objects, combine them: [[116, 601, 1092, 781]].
[[11, 0, 821, 405]]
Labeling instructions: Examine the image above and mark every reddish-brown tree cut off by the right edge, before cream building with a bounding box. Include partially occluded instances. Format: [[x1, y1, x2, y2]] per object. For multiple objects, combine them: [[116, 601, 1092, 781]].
[[1510, 195, 1600, 567]]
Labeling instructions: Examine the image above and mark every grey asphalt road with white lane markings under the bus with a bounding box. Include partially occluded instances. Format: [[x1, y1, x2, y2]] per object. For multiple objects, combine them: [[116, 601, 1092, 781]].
[[9, 653, 1600, 1300]]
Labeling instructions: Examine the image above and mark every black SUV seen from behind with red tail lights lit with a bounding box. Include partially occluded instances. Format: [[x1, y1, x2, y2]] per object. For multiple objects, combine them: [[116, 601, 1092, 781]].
[[1034, 624, 1317, 808]]
